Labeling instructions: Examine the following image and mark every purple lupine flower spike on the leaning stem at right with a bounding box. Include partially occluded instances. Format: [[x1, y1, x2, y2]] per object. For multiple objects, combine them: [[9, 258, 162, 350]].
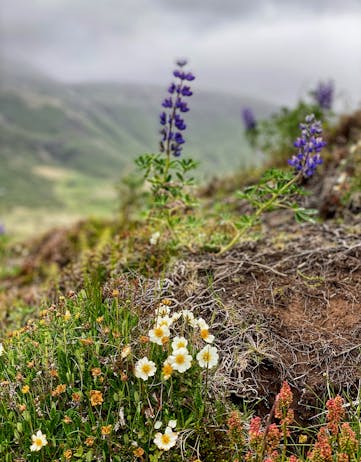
[[288, 114, 326, 178]]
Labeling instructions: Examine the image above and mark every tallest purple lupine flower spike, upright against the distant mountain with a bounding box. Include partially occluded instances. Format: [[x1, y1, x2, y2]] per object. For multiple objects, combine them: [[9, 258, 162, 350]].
[[159, 60, 195, 157]]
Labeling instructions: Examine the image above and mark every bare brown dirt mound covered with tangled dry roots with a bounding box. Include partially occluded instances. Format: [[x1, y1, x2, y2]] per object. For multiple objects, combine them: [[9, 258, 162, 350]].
[[148, 223, 361, 417]]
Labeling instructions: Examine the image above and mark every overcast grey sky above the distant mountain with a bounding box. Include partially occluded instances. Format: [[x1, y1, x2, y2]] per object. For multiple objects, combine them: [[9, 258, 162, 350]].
[[0, 0, 361, 107]]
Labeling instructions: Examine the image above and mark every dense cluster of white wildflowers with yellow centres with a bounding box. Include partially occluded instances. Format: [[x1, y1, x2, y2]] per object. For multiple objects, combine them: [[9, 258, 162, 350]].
[[134, 304, 219, 380]]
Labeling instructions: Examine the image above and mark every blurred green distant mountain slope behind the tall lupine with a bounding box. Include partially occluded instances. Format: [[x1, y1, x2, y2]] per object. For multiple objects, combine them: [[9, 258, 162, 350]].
[[0, 63, 275, 212]]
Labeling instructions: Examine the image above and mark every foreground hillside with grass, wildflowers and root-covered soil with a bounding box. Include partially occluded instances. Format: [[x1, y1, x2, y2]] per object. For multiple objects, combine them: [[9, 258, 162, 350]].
[[0, 107, 361, 462]]
